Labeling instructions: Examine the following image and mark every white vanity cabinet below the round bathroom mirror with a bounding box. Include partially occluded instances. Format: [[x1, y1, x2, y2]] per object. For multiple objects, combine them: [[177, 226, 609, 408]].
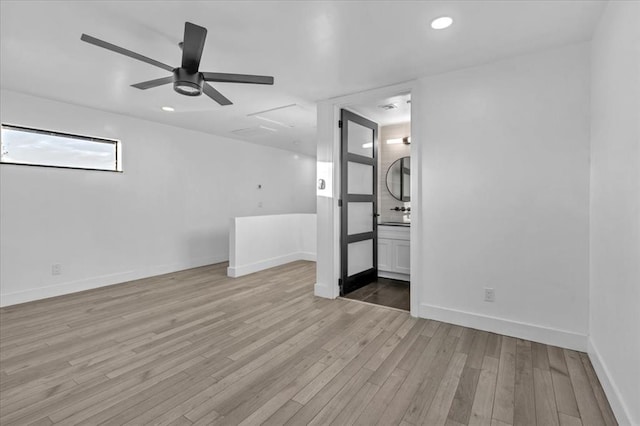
[[378, 224, 411, 281]]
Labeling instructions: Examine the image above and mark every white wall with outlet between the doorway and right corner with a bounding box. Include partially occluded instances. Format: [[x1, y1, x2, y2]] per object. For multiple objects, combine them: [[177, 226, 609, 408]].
[[412, 43, 589, 350]]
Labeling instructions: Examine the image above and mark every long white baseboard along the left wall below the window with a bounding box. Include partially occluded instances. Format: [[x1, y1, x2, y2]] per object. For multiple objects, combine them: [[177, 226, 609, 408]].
[[0, 256, 227, 307]]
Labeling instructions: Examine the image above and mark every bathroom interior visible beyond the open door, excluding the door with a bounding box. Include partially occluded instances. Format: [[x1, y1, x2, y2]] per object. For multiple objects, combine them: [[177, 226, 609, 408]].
[[344, 93, 411, 311]]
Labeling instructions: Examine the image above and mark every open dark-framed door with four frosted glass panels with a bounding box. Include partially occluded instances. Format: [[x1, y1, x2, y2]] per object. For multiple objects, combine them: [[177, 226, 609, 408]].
[[340, 109, 378, 295]]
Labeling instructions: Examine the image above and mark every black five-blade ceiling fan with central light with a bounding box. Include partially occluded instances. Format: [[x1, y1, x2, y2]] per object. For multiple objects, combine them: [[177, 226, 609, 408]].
[[80, 22, 273, 105]]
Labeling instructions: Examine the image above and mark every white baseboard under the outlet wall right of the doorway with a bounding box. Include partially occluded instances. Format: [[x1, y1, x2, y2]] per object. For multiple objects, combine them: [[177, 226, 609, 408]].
[[420, 303, 587, 352]]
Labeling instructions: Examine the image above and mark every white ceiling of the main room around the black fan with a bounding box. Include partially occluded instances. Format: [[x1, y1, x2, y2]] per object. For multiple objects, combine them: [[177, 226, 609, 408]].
[[0, 0, 604, 155]]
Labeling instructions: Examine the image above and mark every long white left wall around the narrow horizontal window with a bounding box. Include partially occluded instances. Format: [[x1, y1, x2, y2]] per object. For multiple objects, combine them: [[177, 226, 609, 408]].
[[0, 90, 315, 305]]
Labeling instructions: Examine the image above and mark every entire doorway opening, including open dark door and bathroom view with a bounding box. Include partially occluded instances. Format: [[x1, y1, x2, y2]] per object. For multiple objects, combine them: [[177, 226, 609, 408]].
[[340, 92, 412, 311]]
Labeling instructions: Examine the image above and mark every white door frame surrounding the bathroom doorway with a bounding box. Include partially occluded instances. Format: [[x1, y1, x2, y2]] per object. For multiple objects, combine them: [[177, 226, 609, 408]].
[[314, 81, 424, 317]]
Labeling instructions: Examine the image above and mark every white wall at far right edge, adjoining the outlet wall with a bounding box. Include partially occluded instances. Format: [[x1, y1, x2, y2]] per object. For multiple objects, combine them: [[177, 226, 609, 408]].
[[589, 1, 640, 425]]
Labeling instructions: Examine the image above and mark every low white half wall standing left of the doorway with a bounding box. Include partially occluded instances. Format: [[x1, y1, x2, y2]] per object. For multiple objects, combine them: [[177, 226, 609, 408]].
[[227, 213, 317, 277]]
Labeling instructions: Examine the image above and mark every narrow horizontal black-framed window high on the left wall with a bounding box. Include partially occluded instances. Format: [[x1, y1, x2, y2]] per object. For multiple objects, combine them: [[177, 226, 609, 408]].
[[0, 124, 122, 172]]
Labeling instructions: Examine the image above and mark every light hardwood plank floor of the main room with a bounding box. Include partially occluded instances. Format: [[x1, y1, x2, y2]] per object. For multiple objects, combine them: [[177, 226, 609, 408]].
[[0, 262, 616, 426]]
